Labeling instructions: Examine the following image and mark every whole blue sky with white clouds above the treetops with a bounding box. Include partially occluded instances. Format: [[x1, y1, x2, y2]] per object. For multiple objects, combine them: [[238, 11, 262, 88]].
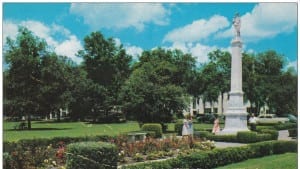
[[2, 2, 298, 70]]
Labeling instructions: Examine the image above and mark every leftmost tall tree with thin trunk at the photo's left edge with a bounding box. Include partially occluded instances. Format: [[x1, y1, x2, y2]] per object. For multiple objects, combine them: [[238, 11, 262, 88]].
[[4, 27, 47, 129]]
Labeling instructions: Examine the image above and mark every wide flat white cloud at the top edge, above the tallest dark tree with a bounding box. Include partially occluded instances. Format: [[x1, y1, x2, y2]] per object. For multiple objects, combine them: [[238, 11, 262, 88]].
[[70, 3, 169, 31]]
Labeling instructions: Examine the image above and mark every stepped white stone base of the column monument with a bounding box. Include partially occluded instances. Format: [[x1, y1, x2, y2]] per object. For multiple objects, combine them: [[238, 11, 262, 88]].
[[217, 107, 250, 135]]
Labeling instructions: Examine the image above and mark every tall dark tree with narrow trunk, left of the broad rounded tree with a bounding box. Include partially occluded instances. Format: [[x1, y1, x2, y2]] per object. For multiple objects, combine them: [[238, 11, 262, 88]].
[[78, 32, 131, 116]]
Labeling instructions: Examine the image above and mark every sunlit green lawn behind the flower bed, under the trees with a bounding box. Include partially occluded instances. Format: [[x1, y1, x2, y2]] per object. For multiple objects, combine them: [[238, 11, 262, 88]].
[[3, 121, 217, 141]]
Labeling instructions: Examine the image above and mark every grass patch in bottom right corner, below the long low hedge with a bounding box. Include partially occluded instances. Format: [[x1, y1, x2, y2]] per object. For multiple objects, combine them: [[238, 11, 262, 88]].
[[217, 153, 297, 169]]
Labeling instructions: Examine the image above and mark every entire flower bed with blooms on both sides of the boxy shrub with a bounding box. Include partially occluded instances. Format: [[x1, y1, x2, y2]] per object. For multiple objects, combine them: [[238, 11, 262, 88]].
[[3, 135, 214, 169]]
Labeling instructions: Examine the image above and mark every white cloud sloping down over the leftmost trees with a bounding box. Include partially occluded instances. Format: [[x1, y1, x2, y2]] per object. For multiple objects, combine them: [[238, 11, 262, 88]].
[[3, 20, 83, 63]]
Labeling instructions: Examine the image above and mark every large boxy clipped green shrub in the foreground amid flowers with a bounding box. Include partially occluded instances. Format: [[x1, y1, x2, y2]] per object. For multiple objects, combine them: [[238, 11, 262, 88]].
[[66, 142, 118, 169]]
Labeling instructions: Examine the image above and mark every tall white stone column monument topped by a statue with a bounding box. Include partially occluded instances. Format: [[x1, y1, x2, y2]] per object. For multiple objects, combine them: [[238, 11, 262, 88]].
[[218, 13, 249, 135]]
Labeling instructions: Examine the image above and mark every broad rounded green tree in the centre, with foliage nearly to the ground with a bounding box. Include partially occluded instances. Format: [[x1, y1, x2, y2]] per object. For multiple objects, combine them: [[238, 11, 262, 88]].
[[121, 49, 187, 123]]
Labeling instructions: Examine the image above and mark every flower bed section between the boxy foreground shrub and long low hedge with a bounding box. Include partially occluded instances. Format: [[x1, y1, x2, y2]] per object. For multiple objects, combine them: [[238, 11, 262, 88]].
[[114, 136, 215, 164]]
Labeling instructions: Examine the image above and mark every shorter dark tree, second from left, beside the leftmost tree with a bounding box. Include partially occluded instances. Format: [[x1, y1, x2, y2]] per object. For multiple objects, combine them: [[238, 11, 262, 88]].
[[39, 53, 74, 121]]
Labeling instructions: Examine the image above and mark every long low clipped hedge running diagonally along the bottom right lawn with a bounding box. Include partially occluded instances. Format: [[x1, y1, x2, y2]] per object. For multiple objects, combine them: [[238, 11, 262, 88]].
[[122, 141, 297, 169]]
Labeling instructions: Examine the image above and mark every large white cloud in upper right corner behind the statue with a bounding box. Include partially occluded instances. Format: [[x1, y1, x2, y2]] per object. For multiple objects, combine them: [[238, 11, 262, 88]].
[[216, 2, 297, 41]]
